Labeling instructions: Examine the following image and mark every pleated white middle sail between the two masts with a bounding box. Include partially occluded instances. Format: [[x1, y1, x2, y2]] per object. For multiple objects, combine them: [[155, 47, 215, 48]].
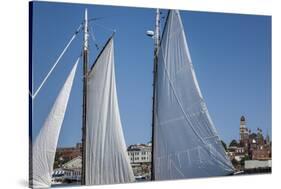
[[85, 38, 134, 185]]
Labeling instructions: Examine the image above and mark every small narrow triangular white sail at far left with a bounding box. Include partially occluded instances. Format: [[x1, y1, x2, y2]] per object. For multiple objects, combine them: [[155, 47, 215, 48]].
[[32, 61, 78, 188]]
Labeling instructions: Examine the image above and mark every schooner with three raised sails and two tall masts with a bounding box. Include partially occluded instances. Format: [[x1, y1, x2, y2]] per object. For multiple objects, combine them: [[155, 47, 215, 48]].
[[30, 4, 233, 188]]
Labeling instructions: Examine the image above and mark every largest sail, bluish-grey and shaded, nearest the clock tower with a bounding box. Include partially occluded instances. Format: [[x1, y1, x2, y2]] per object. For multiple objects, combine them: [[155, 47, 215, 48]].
[[154, 10, 233, 180]]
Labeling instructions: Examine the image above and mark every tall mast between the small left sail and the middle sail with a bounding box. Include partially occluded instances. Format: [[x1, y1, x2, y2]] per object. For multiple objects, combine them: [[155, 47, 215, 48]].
[[81, 9, 89, 185]]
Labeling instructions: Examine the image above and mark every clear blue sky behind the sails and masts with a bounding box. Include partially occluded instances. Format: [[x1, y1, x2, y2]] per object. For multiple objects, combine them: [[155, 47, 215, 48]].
[[32, 2, 271, 146]]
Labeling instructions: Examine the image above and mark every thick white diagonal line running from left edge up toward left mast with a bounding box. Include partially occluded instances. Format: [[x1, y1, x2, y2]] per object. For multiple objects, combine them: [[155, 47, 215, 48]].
[[30, 24, 82, 99]]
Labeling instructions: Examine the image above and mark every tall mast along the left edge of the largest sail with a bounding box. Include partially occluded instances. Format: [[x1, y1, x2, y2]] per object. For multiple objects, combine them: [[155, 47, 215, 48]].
[[151, 9, 160, 180]]
